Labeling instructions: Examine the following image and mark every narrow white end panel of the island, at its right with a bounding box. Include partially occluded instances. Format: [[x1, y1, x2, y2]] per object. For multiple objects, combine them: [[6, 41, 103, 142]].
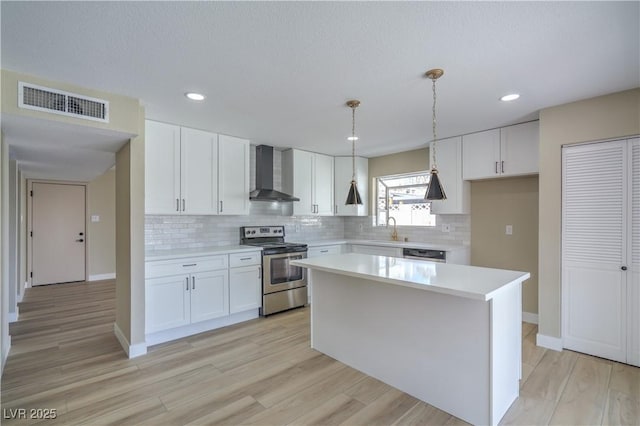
[[490, 283, 522, 424]]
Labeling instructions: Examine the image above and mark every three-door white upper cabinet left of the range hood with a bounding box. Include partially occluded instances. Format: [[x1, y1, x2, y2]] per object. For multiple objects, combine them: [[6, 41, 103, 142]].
[[145, 120, 249, 215]]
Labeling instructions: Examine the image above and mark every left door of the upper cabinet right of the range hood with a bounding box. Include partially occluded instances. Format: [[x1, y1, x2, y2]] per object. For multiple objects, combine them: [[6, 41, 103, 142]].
[[282, 149, 315, 215]]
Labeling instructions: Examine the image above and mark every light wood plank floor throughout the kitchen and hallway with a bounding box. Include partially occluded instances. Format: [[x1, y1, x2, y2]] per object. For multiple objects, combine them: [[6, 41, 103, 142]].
[[1, 281, 640, 425]]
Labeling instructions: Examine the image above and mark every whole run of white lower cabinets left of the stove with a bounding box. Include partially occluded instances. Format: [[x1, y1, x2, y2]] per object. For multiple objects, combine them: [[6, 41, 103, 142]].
[[145, 250, 262, 344]]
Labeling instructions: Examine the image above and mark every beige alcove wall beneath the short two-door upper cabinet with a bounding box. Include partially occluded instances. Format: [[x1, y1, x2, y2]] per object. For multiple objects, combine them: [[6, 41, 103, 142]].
[[471, 176, 538, 314]]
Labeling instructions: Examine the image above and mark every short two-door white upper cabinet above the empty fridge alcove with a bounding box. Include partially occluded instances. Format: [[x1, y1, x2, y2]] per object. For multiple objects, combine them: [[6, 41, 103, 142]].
[[462, 121, 539, 180]]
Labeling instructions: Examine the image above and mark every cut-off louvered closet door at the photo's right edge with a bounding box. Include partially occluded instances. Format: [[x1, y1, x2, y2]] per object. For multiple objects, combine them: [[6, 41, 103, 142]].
[[627, 139, 640, 367]]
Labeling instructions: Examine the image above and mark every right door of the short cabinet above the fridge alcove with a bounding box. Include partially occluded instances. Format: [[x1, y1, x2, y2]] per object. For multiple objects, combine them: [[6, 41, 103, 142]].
[[500, 121, 540, 176]]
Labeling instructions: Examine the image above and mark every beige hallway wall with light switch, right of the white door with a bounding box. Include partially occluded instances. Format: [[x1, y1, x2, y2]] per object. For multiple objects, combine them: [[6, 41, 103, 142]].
[[87, 169, 116, 280]]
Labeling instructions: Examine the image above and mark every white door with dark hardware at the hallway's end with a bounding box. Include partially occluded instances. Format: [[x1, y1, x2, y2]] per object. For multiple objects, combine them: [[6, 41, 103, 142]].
[[31, 183, 86, 285]]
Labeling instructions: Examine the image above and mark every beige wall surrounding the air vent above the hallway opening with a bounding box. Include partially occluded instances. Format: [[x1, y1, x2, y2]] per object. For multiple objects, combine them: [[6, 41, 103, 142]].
[[1, 69, 139, 135]]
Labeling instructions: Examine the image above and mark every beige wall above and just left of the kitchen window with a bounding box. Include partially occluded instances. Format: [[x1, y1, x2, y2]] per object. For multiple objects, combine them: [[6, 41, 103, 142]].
[[369, 148, 429, 207]]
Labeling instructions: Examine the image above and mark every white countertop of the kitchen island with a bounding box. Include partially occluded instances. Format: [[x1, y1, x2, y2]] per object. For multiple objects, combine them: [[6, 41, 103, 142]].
[[291, 253, 531, 301]]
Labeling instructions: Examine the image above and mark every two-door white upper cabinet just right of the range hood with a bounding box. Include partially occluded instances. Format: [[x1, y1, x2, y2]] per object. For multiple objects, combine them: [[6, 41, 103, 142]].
[[282, 149, 334, 216]]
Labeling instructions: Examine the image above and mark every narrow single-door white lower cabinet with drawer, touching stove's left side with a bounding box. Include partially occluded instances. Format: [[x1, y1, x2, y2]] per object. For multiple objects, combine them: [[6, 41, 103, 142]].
[[229, 252, 262, 314]]
